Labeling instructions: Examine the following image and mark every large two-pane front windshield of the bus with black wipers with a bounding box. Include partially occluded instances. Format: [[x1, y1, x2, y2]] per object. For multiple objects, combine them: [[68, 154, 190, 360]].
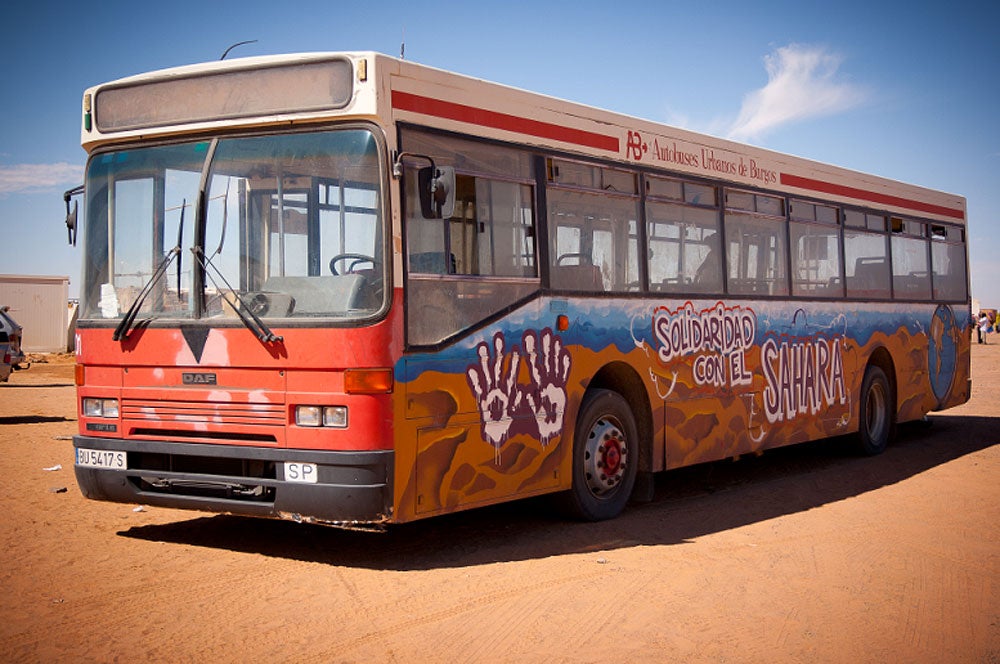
[[81, 128, 387, 321]]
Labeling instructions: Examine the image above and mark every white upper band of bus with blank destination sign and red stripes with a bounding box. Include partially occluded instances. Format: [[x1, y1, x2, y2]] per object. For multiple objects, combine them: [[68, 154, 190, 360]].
[[81, 52, 966, 225]]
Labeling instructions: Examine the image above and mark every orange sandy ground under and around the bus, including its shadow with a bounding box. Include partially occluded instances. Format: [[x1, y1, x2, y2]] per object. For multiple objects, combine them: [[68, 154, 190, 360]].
[[0, 348, 1000, 664]]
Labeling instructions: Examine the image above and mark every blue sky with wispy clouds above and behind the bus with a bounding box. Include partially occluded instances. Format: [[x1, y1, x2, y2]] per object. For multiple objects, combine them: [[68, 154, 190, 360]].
[[0, 0, 1000, 307]]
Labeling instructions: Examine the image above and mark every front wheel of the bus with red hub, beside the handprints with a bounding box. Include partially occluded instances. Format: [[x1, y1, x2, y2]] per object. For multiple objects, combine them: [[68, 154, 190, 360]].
[[562, 390, 639, 521]]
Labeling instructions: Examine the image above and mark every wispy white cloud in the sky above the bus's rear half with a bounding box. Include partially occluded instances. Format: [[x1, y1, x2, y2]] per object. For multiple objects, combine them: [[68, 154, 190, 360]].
[[728, 44, 867, 140]]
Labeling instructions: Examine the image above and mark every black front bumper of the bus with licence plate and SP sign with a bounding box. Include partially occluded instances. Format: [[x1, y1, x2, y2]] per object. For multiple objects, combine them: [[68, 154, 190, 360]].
[[73, 436, 393, 528]]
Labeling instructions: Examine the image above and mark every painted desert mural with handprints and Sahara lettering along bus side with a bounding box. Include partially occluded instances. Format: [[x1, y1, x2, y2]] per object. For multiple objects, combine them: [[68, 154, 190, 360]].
[[400, 298, 967, 511]]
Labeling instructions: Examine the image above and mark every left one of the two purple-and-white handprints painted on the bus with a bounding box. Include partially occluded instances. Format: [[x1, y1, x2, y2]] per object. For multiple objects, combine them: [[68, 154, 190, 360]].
[[466, 332, 523, 449]]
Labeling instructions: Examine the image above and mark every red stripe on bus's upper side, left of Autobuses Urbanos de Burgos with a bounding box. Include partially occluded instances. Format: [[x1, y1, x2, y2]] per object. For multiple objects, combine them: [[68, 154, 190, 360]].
[[392, 90, 620, 152]]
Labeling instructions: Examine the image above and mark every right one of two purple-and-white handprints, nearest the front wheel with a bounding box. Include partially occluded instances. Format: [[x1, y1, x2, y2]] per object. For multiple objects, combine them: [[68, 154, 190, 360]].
[[522, 328, 570, 446]]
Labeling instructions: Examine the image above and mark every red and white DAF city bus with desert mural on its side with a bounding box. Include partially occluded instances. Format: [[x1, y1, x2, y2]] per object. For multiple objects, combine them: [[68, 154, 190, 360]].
[[65, 52, 971, 529]]
